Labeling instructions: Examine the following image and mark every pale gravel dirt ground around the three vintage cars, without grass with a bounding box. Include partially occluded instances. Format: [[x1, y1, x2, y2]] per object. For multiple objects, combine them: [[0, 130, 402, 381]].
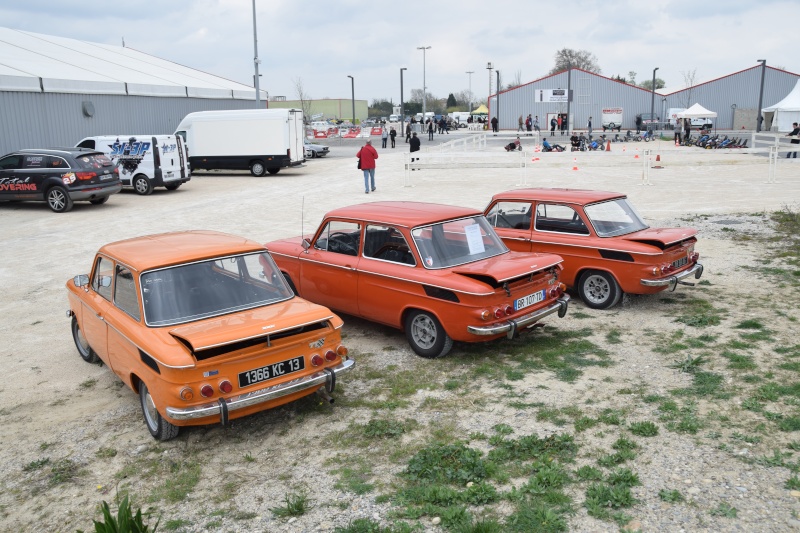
[[0, 134, 800, 531]]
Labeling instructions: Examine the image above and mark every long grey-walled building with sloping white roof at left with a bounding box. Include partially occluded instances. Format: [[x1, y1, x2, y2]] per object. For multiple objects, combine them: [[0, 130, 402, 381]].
[[0, 28, 266, 155]]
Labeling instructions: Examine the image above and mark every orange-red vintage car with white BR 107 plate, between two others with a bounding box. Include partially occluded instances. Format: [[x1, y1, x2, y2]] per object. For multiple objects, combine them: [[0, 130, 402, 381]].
[[267, 202, 569, 358]]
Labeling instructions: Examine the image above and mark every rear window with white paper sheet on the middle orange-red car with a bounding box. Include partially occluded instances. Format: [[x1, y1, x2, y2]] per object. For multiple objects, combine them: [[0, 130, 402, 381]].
[[411, 215, 508, 269]]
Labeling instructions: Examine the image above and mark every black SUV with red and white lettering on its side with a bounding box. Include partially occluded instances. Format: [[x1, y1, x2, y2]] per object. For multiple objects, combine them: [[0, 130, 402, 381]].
[[0, 148, 122, 213]]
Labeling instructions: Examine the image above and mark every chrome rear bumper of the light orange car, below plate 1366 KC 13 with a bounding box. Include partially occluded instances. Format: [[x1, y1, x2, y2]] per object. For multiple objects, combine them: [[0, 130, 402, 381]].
[[167, 359, 356, 420]]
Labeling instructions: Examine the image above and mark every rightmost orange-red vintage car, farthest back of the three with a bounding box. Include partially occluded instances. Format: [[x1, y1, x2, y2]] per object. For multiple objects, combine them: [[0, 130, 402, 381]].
[[485, 189, 703, 309]]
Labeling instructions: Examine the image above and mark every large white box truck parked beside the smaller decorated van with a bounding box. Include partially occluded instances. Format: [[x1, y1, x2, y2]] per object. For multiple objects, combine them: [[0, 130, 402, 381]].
[[175, 109, 305, 176]]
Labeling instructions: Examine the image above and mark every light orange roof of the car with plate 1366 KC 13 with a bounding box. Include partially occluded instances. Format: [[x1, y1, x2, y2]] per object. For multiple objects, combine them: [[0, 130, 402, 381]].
[[100, 230, 265, 272]]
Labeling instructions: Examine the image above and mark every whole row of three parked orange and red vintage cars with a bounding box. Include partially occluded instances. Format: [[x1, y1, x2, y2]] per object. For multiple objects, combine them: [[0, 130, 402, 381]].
[[67, 189, 703, 440]]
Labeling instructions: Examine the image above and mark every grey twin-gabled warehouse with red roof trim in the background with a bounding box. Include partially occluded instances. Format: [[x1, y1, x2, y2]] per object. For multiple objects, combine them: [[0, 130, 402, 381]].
[[489, 65, 800, 133]]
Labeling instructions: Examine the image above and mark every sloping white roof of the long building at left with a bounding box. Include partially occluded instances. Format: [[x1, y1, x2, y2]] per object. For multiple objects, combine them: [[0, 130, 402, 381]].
[[0, 27, 266, 100]]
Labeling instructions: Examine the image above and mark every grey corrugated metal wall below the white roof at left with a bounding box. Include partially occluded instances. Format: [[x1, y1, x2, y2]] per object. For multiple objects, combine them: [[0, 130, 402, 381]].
[[0, 91, 265, 155]]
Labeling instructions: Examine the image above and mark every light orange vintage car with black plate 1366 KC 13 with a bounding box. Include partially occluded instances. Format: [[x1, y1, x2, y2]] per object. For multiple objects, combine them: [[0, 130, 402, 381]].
[[62, 231, 354, 440]]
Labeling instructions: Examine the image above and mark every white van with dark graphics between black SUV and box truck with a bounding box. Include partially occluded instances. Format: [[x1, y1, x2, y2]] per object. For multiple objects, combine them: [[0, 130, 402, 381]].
[[75, 135, 191, 194]]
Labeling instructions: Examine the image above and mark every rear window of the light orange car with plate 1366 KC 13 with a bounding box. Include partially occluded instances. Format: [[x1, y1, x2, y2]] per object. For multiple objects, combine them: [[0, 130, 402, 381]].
[[141, 253, 294, 326]]
